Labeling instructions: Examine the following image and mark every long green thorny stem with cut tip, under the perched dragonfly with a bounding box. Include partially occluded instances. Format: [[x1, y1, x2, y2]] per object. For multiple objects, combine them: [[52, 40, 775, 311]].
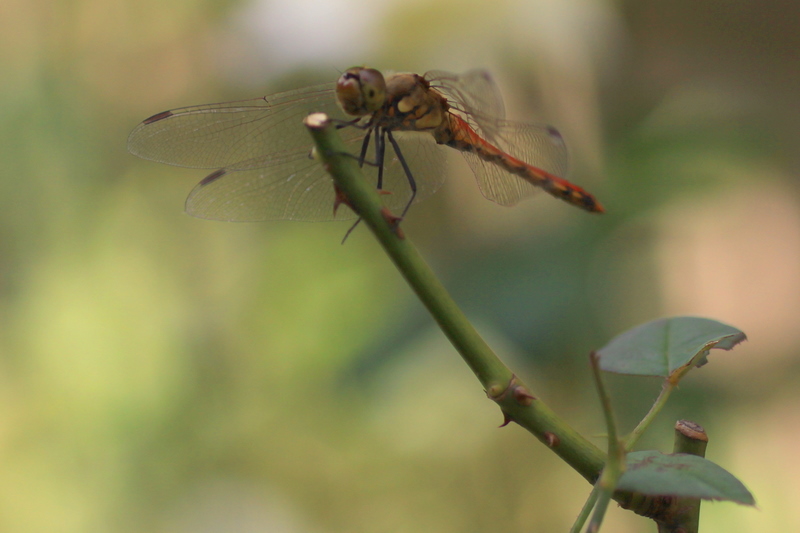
[[306, 113, 605, 483]]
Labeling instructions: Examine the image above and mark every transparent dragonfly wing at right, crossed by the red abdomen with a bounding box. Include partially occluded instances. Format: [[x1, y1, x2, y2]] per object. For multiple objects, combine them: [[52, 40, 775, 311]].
[[463, 120, 567, 206]]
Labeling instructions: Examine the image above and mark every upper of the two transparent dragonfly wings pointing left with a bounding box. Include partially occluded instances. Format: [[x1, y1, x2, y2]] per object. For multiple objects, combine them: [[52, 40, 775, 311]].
[[128, 84, 345, 169]]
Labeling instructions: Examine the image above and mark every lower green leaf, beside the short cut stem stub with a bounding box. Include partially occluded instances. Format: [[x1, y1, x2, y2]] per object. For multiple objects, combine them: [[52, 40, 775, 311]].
[[617, 450, 756, 505]]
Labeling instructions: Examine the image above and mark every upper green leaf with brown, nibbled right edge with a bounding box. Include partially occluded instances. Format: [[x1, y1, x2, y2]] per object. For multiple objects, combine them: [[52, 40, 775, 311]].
[[598, 316, 747, 379]]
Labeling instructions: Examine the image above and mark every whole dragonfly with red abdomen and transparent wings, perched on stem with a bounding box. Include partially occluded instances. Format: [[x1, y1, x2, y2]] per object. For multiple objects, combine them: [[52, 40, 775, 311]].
[[128, 67, 604, 221]]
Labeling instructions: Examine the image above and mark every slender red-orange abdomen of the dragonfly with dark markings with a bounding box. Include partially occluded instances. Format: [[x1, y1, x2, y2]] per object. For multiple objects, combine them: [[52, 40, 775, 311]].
[[435, 113, 605, 213]]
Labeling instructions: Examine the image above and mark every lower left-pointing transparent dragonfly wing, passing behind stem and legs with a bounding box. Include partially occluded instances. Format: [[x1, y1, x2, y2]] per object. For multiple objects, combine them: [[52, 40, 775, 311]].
[[186, 128, 446, 222]]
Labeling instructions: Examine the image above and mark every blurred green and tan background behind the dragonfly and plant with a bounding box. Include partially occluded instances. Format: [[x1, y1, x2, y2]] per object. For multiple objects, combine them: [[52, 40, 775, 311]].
[[0, 0, 800, 533]]
